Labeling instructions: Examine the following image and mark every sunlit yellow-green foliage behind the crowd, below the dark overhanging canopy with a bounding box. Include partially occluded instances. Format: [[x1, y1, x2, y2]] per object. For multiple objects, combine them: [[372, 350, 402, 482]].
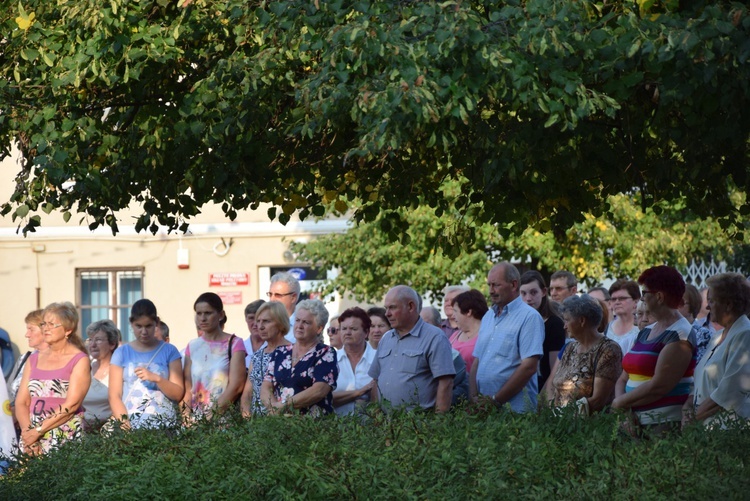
[[291, 185, 735, 301]]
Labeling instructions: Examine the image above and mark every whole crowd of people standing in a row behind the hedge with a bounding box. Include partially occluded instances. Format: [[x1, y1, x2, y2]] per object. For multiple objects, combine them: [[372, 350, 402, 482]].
[[4, 262, 750, 454]]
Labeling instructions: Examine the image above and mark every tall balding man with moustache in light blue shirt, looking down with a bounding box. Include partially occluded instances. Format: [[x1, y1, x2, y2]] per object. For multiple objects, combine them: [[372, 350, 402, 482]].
[[469, 262, 544, 412]]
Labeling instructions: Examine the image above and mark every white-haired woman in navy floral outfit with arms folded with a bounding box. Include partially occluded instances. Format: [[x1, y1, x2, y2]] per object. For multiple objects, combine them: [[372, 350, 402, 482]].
[[261, 299, 339, 416]]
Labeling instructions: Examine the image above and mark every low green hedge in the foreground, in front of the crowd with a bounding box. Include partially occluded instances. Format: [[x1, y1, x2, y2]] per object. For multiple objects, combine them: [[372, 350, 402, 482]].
[[0, 411, 750, 500]]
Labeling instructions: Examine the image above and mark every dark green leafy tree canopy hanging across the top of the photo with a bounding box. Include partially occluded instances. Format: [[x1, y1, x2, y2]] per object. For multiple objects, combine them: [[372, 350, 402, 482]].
[[0, 0, 750, 238]]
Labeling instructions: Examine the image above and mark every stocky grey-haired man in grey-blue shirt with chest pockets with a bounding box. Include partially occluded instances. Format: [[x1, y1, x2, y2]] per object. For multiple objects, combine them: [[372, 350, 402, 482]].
[[369, 285, 456, 412]]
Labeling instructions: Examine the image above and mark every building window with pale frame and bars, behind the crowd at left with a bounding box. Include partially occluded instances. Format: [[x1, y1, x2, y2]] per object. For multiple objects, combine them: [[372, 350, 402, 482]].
[[76, 268, 143, 342]]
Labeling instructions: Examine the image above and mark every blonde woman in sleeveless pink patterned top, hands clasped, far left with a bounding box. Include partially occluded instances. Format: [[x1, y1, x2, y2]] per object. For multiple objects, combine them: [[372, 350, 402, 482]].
[[16, 303, 91, 455]]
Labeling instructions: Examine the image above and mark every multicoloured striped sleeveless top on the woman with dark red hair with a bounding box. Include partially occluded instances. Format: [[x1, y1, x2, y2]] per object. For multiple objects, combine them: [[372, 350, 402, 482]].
[[622, 318, 696, 425]]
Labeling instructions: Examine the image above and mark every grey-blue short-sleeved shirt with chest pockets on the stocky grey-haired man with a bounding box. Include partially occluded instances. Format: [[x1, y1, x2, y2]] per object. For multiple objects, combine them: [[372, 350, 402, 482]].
[[369, 318, 456, 409]]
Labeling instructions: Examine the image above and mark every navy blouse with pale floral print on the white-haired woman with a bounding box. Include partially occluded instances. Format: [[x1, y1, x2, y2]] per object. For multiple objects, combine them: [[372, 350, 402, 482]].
[[263, 343, 339, 416]]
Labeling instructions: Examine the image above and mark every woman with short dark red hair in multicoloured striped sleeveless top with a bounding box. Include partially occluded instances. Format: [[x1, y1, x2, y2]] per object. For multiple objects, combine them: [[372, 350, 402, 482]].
[[612, 266, 695, 433]]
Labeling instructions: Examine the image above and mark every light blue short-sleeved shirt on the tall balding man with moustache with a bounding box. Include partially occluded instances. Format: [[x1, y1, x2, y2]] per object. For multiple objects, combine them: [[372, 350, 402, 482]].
[[474, 296, 544, 412]]
